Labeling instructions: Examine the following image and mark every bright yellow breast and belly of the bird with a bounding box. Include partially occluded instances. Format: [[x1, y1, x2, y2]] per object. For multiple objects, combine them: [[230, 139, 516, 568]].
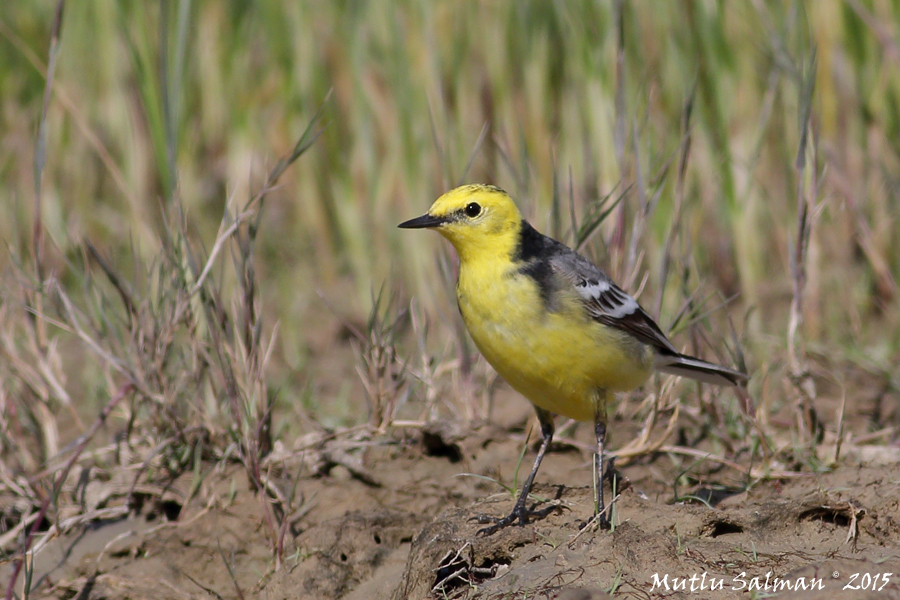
[[457, 268, 653, 421]]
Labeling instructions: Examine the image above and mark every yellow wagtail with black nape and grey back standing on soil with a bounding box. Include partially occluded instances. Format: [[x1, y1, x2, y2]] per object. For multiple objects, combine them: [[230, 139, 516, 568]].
[[399, 185, 747, 535]]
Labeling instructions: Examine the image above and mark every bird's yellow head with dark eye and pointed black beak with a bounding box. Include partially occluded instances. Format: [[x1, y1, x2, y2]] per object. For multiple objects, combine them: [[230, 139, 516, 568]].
[[398, 184, 522, 261]]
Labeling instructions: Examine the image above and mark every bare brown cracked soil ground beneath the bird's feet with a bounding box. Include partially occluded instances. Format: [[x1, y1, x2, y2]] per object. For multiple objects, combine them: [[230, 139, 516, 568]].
[[10, 408, 900, 600]]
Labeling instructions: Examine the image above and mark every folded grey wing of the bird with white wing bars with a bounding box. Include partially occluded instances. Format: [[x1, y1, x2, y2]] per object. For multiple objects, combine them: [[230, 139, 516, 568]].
[[550, 250, 678, 355]]
